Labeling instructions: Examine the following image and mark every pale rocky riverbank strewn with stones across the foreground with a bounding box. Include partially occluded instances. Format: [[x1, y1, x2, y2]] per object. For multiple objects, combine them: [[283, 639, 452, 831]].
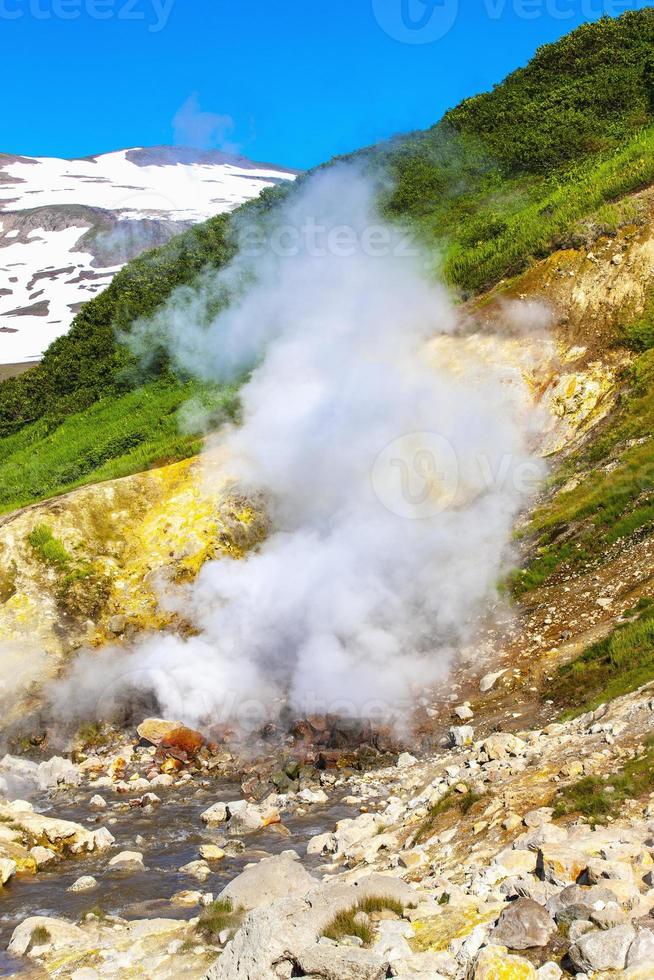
[[0, 686, 654, 980]]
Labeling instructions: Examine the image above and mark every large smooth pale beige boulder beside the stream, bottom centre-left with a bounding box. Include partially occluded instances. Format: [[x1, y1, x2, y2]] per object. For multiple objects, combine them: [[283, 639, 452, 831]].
[[220, 851, 318, 911]]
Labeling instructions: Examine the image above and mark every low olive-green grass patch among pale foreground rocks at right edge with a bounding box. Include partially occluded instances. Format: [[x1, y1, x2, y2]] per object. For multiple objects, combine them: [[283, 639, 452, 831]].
[[554, 737, 654, 824]]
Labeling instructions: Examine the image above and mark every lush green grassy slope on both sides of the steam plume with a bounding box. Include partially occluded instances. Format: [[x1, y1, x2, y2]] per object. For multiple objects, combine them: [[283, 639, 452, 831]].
[[0, 9, 654, 510]]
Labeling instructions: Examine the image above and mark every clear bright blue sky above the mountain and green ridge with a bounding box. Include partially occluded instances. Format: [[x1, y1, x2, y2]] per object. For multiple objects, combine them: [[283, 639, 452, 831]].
[[0, 0, 648, 168]]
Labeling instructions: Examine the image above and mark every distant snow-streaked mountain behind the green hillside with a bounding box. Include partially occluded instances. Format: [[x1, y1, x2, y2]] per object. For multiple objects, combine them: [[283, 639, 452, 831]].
[[0, 146, 296, 364]]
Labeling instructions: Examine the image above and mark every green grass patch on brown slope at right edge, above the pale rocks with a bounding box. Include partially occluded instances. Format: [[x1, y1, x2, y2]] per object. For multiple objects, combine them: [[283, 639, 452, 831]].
[[543, 600, 654, 720]]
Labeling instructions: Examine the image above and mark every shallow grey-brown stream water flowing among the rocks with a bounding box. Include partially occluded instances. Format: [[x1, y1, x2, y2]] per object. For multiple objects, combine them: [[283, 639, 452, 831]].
[[0, 781, 355, 976]]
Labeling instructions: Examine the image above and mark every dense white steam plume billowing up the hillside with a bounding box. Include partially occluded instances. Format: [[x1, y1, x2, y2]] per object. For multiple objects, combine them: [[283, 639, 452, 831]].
[[51, 167, 541, 724]]
